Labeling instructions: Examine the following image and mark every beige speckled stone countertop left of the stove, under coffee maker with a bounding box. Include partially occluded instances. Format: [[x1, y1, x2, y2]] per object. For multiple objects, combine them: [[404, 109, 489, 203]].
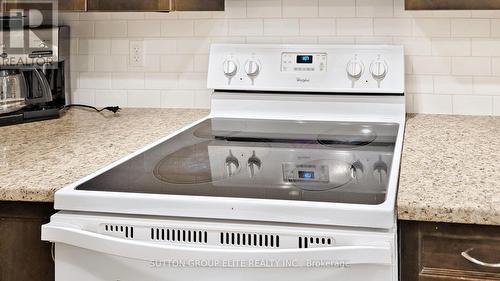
[[0, 109, 208, 202]]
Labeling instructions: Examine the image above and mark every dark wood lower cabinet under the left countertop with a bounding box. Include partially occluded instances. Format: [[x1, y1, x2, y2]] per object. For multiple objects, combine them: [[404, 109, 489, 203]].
[[0, 202, 55, 281]]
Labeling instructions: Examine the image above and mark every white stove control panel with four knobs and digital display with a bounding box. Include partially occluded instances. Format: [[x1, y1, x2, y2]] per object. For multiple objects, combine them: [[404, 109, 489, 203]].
[[208, 44, 405, 95]]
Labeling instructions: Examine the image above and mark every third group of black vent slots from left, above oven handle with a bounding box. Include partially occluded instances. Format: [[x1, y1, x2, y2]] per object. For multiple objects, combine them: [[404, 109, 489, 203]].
[[220, 232, 280, 248]]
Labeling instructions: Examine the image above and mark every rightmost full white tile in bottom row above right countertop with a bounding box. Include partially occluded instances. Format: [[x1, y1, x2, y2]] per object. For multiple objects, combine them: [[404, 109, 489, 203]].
[[453, 95, 493, 115]]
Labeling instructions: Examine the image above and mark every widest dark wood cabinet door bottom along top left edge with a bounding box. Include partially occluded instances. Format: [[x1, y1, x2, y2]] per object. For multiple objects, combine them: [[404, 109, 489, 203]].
[[87, 0, 171, 12]]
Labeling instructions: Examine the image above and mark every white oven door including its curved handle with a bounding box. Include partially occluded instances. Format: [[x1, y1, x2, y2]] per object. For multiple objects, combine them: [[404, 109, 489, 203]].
[[42, 223, 396, 281]]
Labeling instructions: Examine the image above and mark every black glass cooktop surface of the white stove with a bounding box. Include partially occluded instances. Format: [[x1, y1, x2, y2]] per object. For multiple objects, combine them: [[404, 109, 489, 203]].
[[76, 118, 399, 204]]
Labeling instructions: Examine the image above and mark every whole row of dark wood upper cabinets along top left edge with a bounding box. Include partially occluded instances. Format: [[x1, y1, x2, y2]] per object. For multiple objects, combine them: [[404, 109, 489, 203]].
[[0, 0, 224, 12]]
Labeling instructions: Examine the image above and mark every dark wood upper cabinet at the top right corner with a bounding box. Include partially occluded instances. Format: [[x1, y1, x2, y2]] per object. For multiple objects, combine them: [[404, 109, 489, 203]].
[[405, 0, 500, 10]]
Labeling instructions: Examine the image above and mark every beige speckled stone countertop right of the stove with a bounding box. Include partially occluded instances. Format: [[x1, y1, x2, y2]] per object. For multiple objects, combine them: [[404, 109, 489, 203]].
[[397, 115, 500, 225]]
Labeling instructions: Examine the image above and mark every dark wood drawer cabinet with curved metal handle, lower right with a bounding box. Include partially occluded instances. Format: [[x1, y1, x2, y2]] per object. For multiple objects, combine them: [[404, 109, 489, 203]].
[[399, 221, 500, 281]]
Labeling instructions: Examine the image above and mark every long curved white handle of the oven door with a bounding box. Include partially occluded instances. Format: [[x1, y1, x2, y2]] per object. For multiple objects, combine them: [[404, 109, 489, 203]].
[[42, 223, 393, 267]]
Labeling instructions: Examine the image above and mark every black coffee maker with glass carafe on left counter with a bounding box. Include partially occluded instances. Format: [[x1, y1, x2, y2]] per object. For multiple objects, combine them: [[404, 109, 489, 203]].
[[0, 26, 71, 126]]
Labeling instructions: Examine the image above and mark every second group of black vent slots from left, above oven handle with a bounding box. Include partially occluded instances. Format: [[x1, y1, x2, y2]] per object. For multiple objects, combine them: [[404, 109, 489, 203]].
[[151, 227, 208, 244]]
